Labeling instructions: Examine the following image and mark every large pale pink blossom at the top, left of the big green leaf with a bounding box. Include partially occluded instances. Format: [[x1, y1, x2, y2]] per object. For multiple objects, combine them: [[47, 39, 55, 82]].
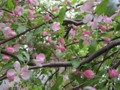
[[80, 2, 94, 12]]
